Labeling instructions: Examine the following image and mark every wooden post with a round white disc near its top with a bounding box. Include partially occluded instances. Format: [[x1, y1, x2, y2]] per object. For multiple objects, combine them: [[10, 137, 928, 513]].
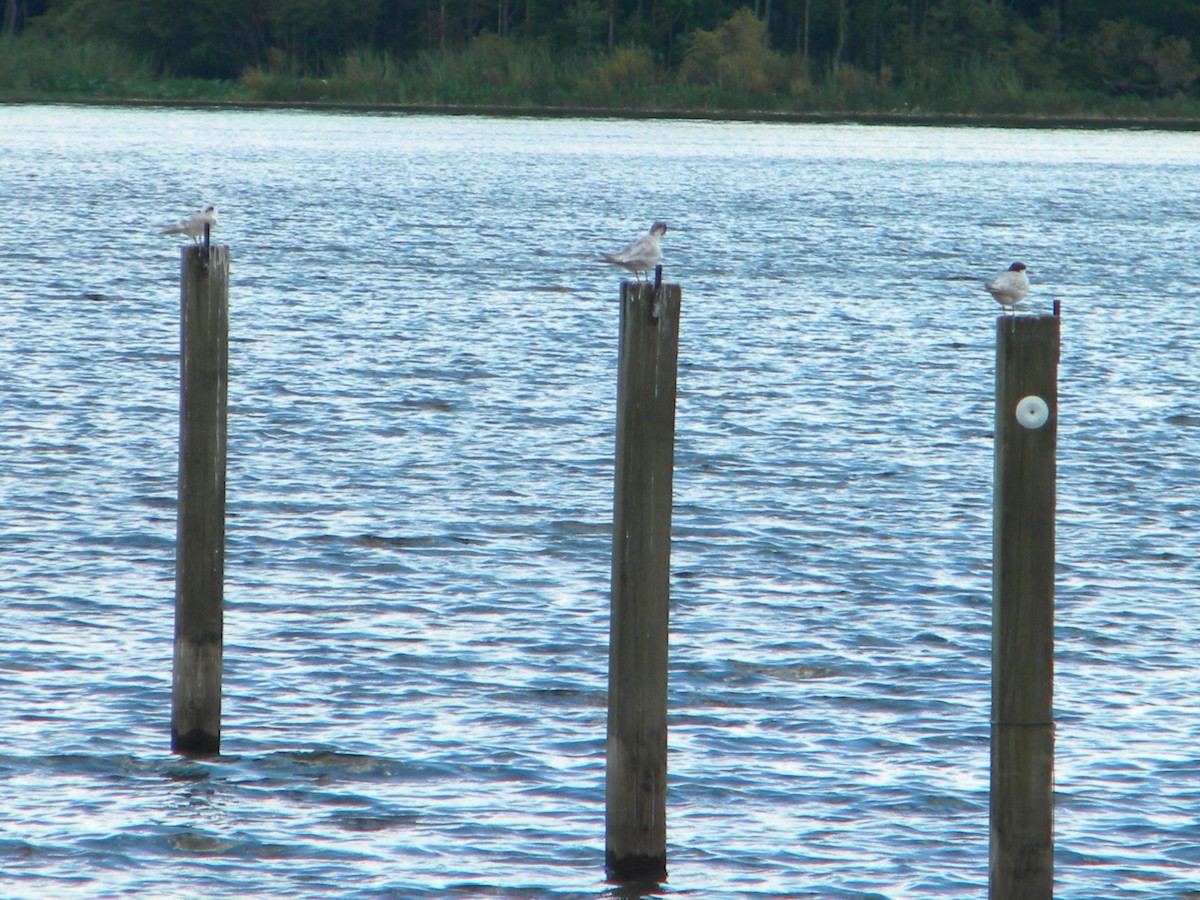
[[989, 305, 1060, 900]]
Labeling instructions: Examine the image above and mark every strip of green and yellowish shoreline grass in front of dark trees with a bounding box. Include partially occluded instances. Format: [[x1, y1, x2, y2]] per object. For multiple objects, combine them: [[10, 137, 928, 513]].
[[7, 35, 1200, 131]]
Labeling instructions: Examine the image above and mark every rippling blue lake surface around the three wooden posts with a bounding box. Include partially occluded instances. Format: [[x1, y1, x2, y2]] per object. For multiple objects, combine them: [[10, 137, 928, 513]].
[[0, 106, 1200, 900]]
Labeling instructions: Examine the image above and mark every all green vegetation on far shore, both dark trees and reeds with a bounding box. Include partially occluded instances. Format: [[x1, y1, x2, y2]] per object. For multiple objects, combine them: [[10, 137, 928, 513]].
[[0, 0, 1200, 119]]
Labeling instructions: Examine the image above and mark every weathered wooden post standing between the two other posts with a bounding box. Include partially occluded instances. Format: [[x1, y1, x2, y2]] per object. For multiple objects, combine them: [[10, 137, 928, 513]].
[[605, 268, 682, 881]]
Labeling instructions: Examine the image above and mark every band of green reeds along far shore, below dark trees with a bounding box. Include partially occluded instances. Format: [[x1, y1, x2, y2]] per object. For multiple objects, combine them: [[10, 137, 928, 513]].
[[0, 32, 1200, 120]]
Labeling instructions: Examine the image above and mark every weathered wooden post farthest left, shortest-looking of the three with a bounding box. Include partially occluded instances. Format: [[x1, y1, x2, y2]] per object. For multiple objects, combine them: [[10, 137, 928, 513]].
[[170, 234, 229, 756]]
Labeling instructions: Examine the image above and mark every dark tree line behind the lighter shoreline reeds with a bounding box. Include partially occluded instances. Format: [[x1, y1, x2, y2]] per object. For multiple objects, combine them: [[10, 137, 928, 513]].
[[9, 0, 1200, 97]]
